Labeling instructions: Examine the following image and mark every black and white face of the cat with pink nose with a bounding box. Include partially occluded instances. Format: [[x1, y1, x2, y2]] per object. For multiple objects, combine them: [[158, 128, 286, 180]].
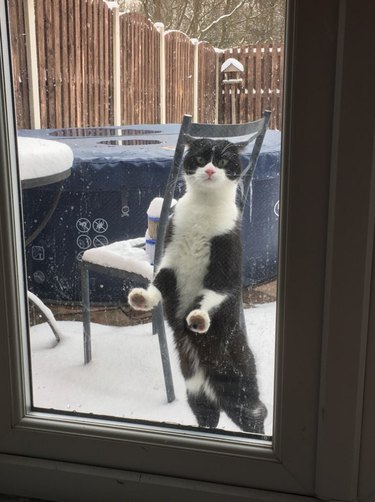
[[184, 137, 241, 190]]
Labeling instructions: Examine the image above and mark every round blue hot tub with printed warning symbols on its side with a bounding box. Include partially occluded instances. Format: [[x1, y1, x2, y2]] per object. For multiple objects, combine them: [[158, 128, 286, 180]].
[[19, 124, 280, 303]]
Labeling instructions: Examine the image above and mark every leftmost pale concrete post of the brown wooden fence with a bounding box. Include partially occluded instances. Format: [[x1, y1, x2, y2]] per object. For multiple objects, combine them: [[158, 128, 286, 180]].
[[23, 0, 41, 129]]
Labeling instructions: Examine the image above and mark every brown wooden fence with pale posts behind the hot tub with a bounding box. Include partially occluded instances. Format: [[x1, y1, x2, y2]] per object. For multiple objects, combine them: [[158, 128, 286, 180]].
[[9, 0, 283, 129]]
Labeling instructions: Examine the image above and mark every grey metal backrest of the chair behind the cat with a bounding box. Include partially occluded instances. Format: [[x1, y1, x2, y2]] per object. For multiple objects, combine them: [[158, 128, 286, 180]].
[[154, 111, 271, 267]]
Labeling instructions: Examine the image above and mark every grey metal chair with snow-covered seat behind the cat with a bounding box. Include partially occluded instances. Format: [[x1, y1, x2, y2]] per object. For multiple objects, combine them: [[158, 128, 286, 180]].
[[81, 111, 270, 402]]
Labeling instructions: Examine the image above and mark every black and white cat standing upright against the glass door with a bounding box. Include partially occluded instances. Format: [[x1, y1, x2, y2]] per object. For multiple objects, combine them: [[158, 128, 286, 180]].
[[129, 138, 267, 433]]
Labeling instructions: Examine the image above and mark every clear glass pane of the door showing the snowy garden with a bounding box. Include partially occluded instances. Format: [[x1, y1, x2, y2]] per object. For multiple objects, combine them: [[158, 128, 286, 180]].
[[8, 0, 285, 440]]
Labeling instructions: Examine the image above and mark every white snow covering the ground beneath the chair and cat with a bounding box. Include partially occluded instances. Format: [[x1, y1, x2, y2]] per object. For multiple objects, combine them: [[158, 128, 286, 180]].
[[30, 302, 276, 436]]
